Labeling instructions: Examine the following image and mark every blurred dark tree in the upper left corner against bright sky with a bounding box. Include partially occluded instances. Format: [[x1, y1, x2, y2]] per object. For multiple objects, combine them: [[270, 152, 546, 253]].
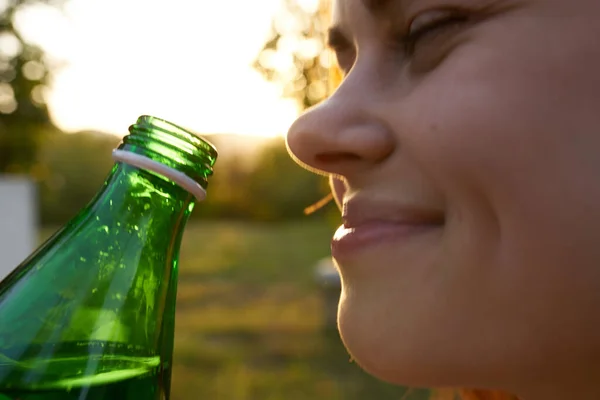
[[0, 0, 59, 173]]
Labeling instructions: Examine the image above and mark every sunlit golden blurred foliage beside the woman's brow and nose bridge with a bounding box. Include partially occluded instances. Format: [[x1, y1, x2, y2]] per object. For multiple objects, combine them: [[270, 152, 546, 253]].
[[254, 0, 332, 109]]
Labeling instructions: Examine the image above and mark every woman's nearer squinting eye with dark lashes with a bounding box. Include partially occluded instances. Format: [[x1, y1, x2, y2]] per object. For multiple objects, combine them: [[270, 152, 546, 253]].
[[402, 9, 469, 55]]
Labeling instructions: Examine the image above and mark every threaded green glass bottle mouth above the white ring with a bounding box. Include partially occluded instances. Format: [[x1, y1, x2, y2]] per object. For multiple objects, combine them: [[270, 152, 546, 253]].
[[117, 115, 218, 189]]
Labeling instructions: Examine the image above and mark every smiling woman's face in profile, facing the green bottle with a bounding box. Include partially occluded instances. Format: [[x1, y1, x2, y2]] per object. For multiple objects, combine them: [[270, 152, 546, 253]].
[[287, 0, 600, 392]]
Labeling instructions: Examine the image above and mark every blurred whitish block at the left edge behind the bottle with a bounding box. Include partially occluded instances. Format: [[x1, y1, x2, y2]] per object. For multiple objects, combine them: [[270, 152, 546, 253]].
[[0, 175, 38, 280]]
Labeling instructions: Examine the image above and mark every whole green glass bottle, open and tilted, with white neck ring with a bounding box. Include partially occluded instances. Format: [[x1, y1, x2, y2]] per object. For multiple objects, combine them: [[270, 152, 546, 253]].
[[0, 116, 217, 400]]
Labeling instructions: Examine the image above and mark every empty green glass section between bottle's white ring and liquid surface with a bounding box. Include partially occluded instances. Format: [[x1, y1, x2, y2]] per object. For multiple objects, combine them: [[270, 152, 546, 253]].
[[0, 159, 196, 350]]
